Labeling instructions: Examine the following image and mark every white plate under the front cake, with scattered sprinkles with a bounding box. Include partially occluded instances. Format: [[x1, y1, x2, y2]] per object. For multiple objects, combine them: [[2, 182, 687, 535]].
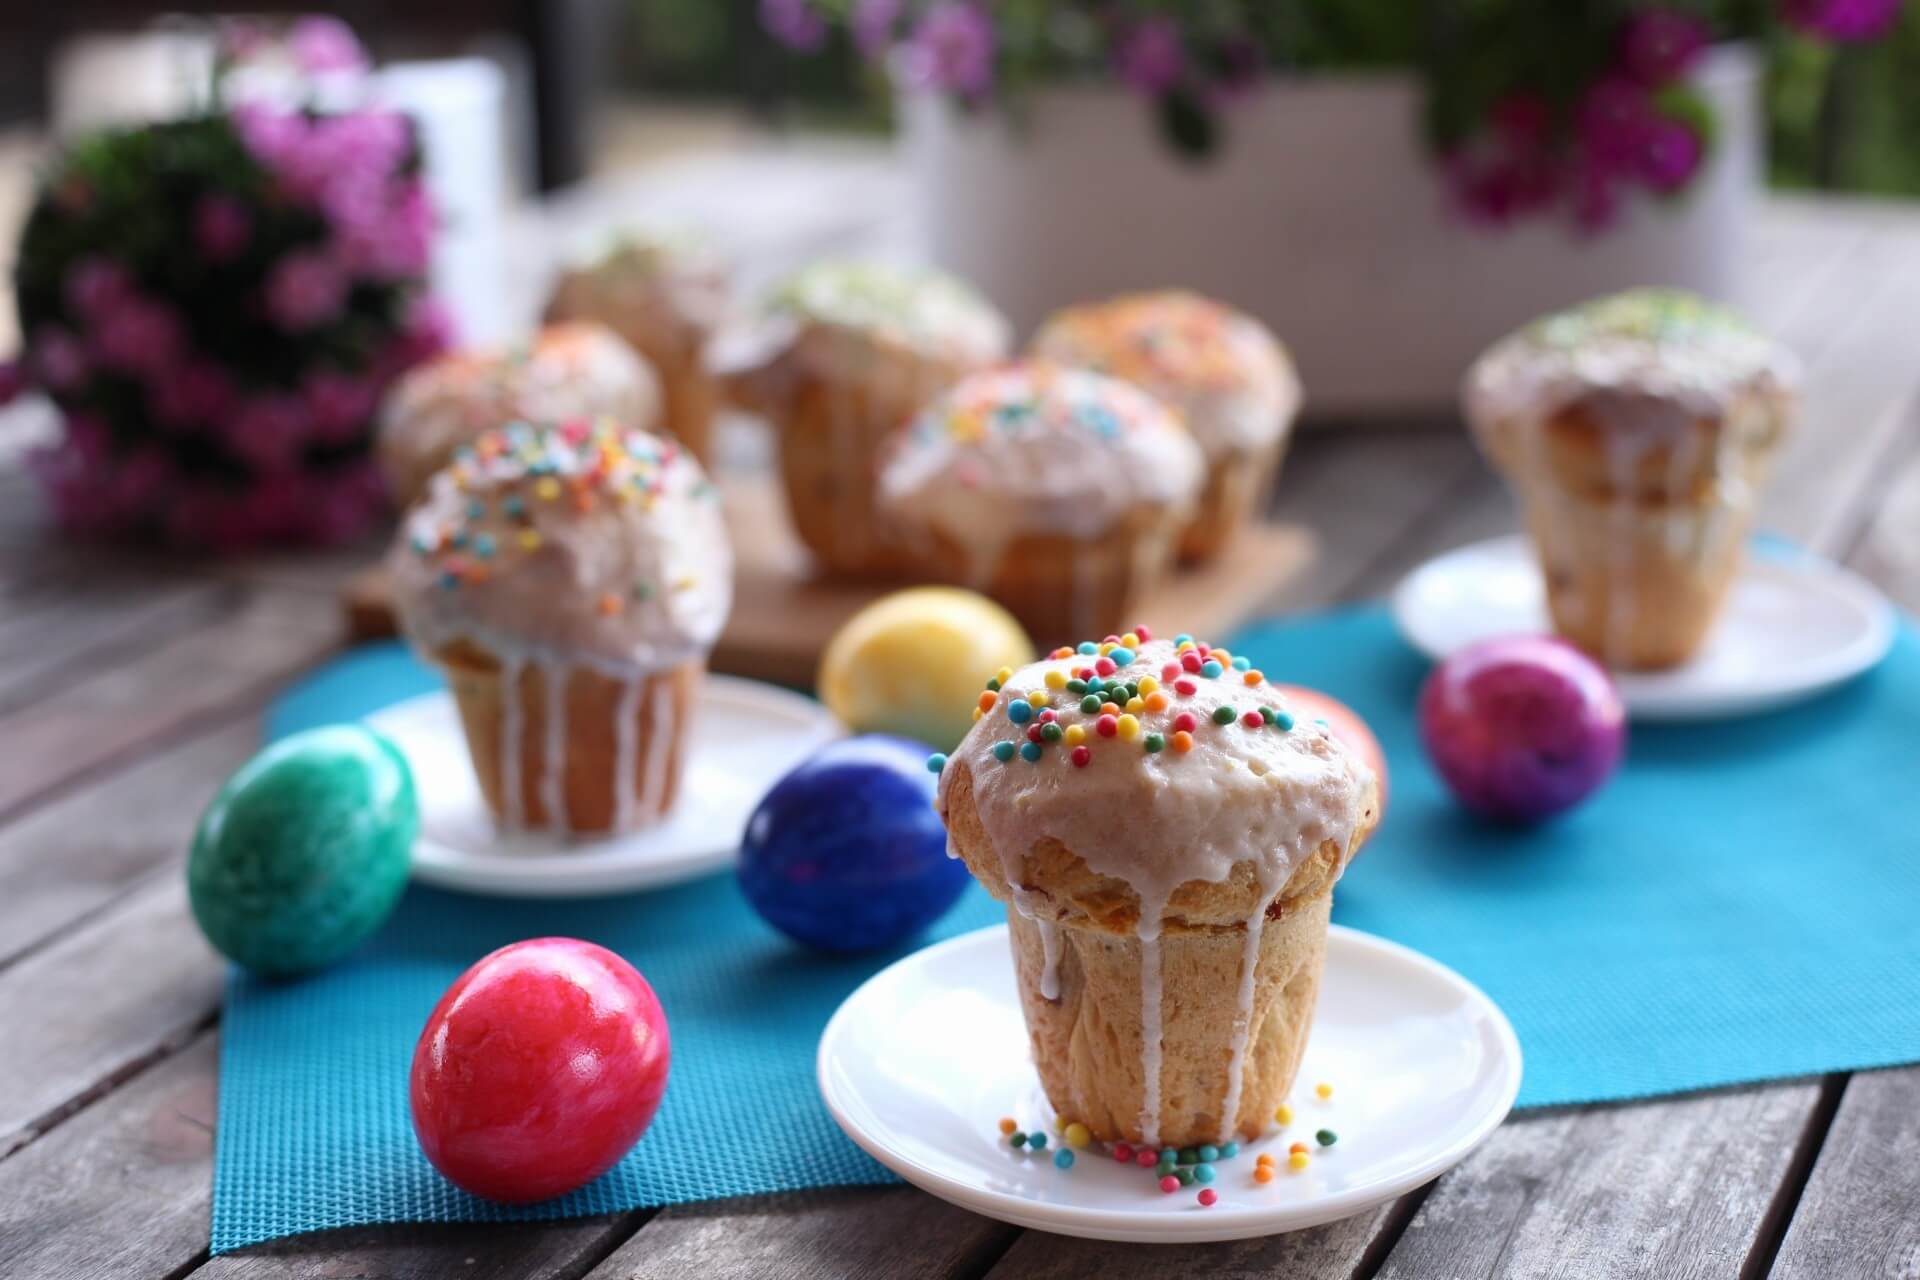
[[818, 925, 1521, 1244]]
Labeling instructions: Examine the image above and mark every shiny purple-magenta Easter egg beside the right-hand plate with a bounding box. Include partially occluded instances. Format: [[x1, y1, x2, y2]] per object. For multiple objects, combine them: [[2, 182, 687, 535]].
[[1419, 635, 1626, 821]]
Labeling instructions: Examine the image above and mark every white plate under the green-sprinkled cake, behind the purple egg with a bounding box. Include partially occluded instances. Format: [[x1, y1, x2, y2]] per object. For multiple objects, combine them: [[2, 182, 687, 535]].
[[1394, 537, 1893, 720]]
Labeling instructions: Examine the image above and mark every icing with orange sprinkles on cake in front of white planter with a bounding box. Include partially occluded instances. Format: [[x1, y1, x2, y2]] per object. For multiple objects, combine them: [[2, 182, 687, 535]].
[[1029, 290, 1300, 459]]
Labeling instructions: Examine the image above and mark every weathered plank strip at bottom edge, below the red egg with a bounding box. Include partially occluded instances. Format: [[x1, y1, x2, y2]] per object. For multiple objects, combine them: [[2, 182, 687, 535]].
[[194, 1213, 647, 1280]]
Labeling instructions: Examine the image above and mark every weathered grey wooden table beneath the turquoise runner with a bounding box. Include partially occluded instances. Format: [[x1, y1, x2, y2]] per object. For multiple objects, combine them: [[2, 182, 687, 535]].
[[0, 172, 1920, 1280]]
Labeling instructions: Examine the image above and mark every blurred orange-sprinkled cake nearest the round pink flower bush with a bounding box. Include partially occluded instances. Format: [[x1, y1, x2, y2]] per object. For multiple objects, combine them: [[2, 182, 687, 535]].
[[374, 324, 660, 507]]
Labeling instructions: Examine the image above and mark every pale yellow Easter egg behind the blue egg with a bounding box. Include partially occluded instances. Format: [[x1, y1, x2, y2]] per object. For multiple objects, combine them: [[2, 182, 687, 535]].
[[818, 587, 1033, 750]]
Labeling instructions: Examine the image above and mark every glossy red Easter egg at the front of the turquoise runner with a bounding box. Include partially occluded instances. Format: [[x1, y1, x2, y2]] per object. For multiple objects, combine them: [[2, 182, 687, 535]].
[[411, 938, 672, 1203]]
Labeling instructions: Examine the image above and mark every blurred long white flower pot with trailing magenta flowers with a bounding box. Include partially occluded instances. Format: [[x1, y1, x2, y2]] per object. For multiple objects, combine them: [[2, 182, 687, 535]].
[[900, 46, 1761, 415]]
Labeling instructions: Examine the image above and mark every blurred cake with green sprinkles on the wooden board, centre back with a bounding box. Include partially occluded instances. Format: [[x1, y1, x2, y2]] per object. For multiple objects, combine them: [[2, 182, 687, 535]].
[[730, 261, 1010, 576]]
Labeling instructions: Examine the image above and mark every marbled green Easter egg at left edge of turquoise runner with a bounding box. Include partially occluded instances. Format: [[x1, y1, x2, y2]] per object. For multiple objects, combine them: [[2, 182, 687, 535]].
[[186, 725, 420, 977]]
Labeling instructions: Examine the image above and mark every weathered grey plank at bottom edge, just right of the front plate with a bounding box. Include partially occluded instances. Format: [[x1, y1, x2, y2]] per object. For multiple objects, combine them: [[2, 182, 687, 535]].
[[1380, 1082, 1820, 1280]]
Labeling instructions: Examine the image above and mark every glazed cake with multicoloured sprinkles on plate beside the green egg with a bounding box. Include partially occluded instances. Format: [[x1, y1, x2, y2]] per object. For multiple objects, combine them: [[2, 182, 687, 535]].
[[388, 420, 732, 833]]
